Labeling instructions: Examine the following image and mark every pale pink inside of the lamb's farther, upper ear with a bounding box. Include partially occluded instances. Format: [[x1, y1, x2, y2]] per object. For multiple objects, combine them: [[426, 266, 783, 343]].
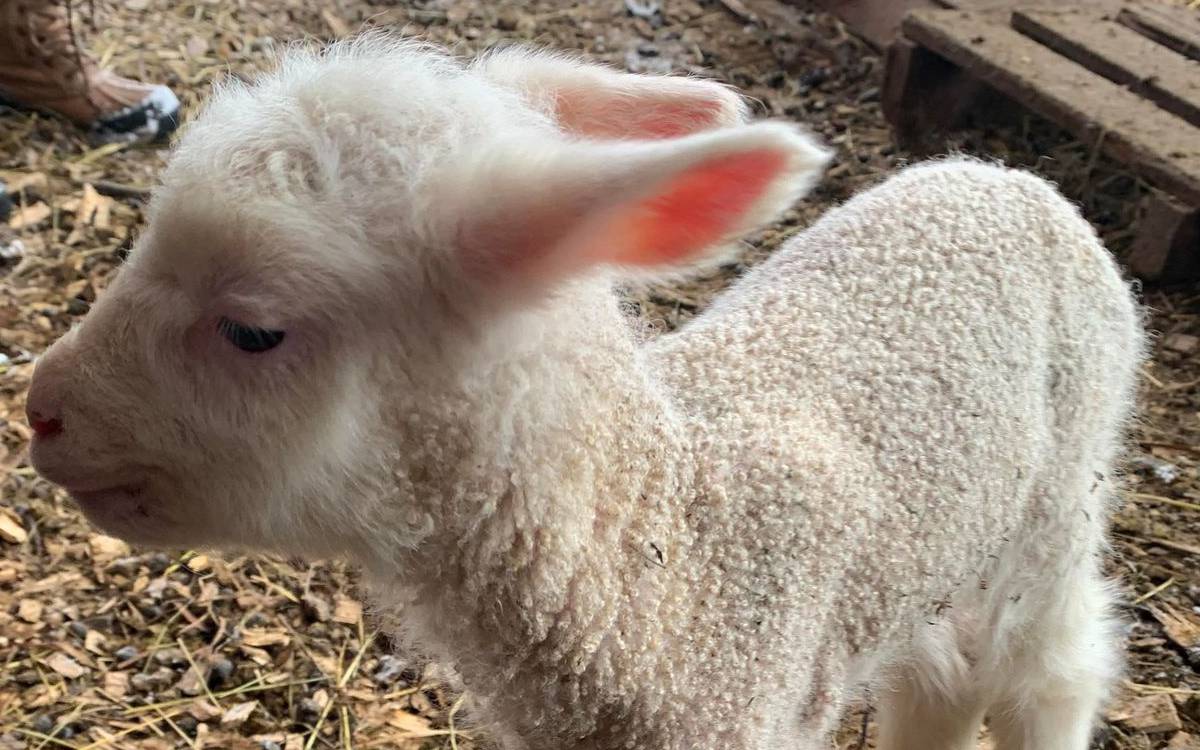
[[556, 90, 722, 139]]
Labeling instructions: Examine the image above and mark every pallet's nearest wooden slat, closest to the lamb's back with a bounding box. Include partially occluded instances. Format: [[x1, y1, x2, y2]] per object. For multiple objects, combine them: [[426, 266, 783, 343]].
[[902, 11, 1200, 205]]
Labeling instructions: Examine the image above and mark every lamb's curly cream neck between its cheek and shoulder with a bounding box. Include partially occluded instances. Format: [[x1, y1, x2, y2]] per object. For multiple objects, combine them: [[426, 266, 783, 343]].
[[360, 283, 691, 700]]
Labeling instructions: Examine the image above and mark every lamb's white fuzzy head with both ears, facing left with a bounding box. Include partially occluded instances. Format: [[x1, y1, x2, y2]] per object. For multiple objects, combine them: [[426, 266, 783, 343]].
[[28, 38, 827, 554]]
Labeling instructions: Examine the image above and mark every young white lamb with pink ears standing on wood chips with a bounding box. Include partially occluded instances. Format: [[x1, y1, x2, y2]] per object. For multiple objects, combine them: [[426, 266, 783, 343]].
[[28, 36, 1144, 750]]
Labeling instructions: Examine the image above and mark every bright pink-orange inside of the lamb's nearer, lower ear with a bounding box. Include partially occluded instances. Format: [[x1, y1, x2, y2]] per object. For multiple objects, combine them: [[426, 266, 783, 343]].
[[589, 149, 787, 265]]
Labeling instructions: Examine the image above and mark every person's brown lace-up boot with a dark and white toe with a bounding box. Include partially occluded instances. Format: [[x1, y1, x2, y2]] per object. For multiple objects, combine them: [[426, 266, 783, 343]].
[[0, 0, 179, 143]]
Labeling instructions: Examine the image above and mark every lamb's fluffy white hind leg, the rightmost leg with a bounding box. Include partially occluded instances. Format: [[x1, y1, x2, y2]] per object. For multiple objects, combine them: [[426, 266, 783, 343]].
[[988, 562, 1121, 750]]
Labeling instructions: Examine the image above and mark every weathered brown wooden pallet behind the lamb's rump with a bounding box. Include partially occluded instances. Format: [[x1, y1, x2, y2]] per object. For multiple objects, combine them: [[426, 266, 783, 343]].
[[883, 0, 1200, 283]]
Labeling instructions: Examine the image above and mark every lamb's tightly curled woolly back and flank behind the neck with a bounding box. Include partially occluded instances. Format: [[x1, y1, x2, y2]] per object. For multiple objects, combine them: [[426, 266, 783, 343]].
[[648, 161, 1140, 686]]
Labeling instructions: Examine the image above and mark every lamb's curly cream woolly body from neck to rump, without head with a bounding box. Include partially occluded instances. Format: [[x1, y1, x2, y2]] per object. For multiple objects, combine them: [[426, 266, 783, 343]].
[[367, 162, 1141, 750]]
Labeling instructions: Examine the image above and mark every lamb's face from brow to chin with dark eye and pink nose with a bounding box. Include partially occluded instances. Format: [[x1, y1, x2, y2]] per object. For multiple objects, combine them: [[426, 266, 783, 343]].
[[28, 188, 392, 551]]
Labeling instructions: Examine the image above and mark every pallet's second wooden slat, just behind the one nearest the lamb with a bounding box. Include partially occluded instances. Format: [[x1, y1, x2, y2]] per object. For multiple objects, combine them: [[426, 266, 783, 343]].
[[1013, 7, 1200, 125]]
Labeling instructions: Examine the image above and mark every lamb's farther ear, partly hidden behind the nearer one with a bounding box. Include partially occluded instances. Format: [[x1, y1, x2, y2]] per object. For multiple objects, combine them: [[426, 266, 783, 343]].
[[476, 48, 746, 140]]
